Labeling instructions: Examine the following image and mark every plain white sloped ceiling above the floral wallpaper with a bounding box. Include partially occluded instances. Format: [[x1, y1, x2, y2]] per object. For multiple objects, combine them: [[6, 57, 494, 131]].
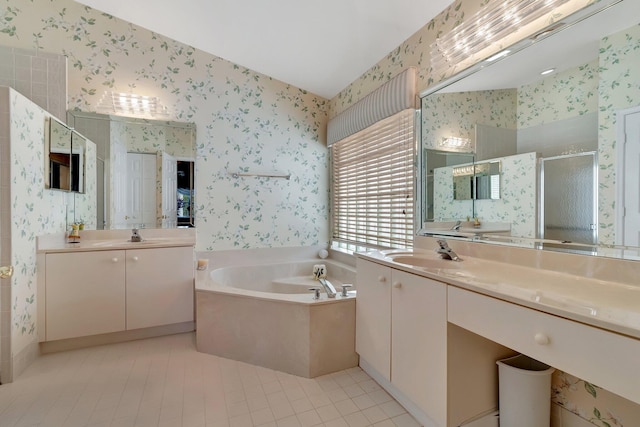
[[76, 0, 451, 98]]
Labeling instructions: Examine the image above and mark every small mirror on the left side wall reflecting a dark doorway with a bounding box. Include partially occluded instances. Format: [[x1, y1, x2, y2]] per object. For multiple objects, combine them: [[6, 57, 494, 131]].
[[44, 117, 87, 193]]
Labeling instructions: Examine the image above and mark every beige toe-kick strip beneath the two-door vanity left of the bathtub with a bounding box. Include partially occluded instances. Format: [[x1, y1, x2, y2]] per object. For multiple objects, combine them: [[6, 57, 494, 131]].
[[39, 321, 196, 356]]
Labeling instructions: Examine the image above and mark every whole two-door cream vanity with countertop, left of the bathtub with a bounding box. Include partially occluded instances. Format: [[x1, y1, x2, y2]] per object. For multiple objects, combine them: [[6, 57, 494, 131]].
[[38, 230, 194, 352]]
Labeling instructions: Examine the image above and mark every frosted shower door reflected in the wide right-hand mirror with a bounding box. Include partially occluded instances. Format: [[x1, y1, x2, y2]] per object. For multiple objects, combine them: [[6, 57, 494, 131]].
[[540, 152, 598, 245]]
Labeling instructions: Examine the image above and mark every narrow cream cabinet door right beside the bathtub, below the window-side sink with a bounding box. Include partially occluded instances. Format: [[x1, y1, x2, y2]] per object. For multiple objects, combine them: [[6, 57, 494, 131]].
[[356, 259, 391, 380]]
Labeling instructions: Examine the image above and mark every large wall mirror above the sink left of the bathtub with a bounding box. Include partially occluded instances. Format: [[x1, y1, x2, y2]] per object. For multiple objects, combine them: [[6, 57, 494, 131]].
[[68, 111, 196, 229]]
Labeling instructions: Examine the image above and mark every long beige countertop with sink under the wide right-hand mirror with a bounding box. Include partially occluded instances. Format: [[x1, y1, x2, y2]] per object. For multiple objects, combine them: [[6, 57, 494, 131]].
[[357, 249, 640, 339]]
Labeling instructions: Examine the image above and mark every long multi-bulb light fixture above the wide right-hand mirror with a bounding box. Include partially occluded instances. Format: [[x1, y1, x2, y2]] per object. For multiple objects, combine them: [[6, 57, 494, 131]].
[[431, 0, 569, 74]]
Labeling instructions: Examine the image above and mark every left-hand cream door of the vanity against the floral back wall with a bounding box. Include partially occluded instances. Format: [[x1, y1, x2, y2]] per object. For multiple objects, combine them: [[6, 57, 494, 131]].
[[45, 251, 125, 341]]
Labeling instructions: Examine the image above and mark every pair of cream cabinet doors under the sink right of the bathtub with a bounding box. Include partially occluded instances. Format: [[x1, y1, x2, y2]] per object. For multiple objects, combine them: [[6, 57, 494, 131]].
[[356, 259, 447, 426]]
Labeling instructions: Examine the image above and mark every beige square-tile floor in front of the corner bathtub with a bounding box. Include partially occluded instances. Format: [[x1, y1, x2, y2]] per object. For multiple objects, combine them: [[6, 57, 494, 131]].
[[0, 333, 418, 427]]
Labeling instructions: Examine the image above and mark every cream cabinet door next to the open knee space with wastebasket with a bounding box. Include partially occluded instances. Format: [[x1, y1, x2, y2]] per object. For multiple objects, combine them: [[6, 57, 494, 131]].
[[390, 270, 447, 426]]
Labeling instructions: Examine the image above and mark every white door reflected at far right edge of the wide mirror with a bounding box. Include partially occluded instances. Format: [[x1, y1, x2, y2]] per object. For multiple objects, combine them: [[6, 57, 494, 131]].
[[616, 107, 640, 246]]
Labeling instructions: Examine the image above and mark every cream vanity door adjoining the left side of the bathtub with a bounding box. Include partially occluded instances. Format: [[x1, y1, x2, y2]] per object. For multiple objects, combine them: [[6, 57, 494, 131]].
[[127, 247, 193, 330]]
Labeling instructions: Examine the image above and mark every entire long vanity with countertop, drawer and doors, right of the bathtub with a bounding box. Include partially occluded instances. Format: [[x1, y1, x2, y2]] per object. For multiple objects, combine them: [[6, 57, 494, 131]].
[[356, 242, 640, 426]]
